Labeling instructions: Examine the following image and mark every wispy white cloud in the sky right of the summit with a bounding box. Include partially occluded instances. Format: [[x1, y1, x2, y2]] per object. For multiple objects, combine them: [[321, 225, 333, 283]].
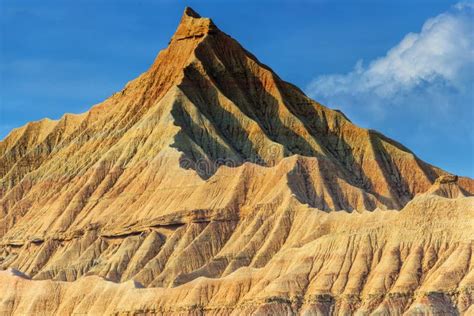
[[307, 2, 474, 112]]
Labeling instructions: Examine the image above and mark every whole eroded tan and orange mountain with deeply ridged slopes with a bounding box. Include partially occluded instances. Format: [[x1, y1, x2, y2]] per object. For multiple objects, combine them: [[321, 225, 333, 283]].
[[0, 8, 474, 315]]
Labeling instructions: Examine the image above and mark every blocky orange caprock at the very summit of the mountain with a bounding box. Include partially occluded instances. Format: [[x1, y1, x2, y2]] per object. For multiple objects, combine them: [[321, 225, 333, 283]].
[[171, 7, 219, 41]]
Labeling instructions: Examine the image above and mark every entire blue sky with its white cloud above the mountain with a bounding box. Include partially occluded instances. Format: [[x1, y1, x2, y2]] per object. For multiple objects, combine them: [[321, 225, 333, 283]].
[[0, 0, 474, 177]]
